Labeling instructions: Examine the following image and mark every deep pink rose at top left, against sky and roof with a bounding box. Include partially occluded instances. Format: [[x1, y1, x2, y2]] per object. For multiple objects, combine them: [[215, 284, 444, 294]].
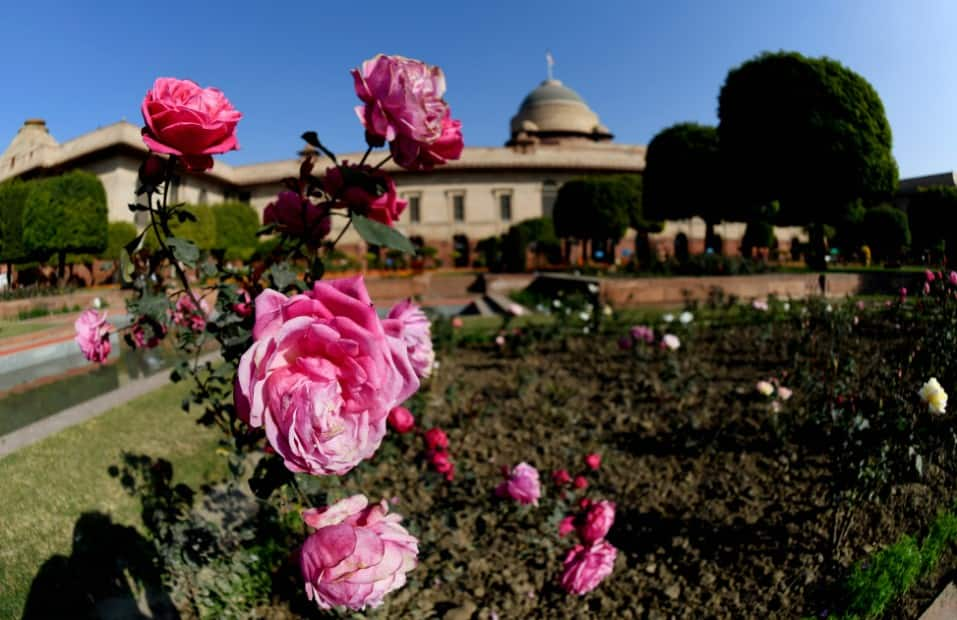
[[140, 78, 243, 170]]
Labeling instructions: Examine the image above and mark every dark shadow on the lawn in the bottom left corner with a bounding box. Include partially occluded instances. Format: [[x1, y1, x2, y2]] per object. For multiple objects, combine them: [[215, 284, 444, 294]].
[[23, 512, 179, 619]]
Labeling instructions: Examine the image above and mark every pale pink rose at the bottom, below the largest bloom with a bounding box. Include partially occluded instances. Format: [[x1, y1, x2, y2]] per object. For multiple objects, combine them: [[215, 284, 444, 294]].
[[299, 495, 419, 610]]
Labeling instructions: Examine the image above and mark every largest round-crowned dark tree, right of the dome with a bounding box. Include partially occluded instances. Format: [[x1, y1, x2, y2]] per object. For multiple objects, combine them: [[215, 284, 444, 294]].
[[718, 52, 897, 267]]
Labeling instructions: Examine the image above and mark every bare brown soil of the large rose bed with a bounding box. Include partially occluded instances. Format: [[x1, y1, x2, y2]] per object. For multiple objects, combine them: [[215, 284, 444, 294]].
[[278, 326, 955, 618]]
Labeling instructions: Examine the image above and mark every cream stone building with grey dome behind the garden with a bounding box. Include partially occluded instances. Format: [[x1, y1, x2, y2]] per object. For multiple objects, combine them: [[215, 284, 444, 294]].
[[0, 79, 800, 262]]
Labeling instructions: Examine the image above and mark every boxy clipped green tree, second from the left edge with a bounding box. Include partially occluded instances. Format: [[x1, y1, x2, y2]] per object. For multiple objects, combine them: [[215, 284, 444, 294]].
[[22, 170, 108, 283]]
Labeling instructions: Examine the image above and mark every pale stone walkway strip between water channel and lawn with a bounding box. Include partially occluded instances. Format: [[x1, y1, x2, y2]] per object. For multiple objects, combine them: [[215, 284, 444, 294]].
[[0, 352, 219, 458]]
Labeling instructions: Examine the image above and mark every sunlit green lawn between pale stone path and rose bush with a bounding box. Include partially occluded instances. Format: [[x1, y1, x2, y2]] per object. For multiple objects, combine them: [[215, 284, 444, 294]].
[[0, 384, 226, 618]]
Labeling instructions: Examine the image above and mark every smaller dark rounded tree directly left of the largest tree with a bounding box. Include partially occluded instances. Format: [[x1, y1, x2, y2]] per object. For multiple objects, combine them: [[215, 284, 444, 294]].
[[643, 123, 737, 251]]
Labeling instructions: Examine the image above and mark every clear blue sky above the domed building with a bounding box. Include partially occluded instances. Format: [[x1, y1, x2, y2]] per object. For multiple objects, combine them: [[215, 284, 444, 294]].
[[0, 0, 957, 177]]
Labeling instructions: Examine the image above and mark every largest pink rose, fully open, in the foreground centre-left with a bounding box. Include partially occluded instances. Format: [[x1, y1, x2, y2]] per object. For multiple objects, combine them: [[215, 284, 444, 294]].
[[235, 276, 419, 475]]
